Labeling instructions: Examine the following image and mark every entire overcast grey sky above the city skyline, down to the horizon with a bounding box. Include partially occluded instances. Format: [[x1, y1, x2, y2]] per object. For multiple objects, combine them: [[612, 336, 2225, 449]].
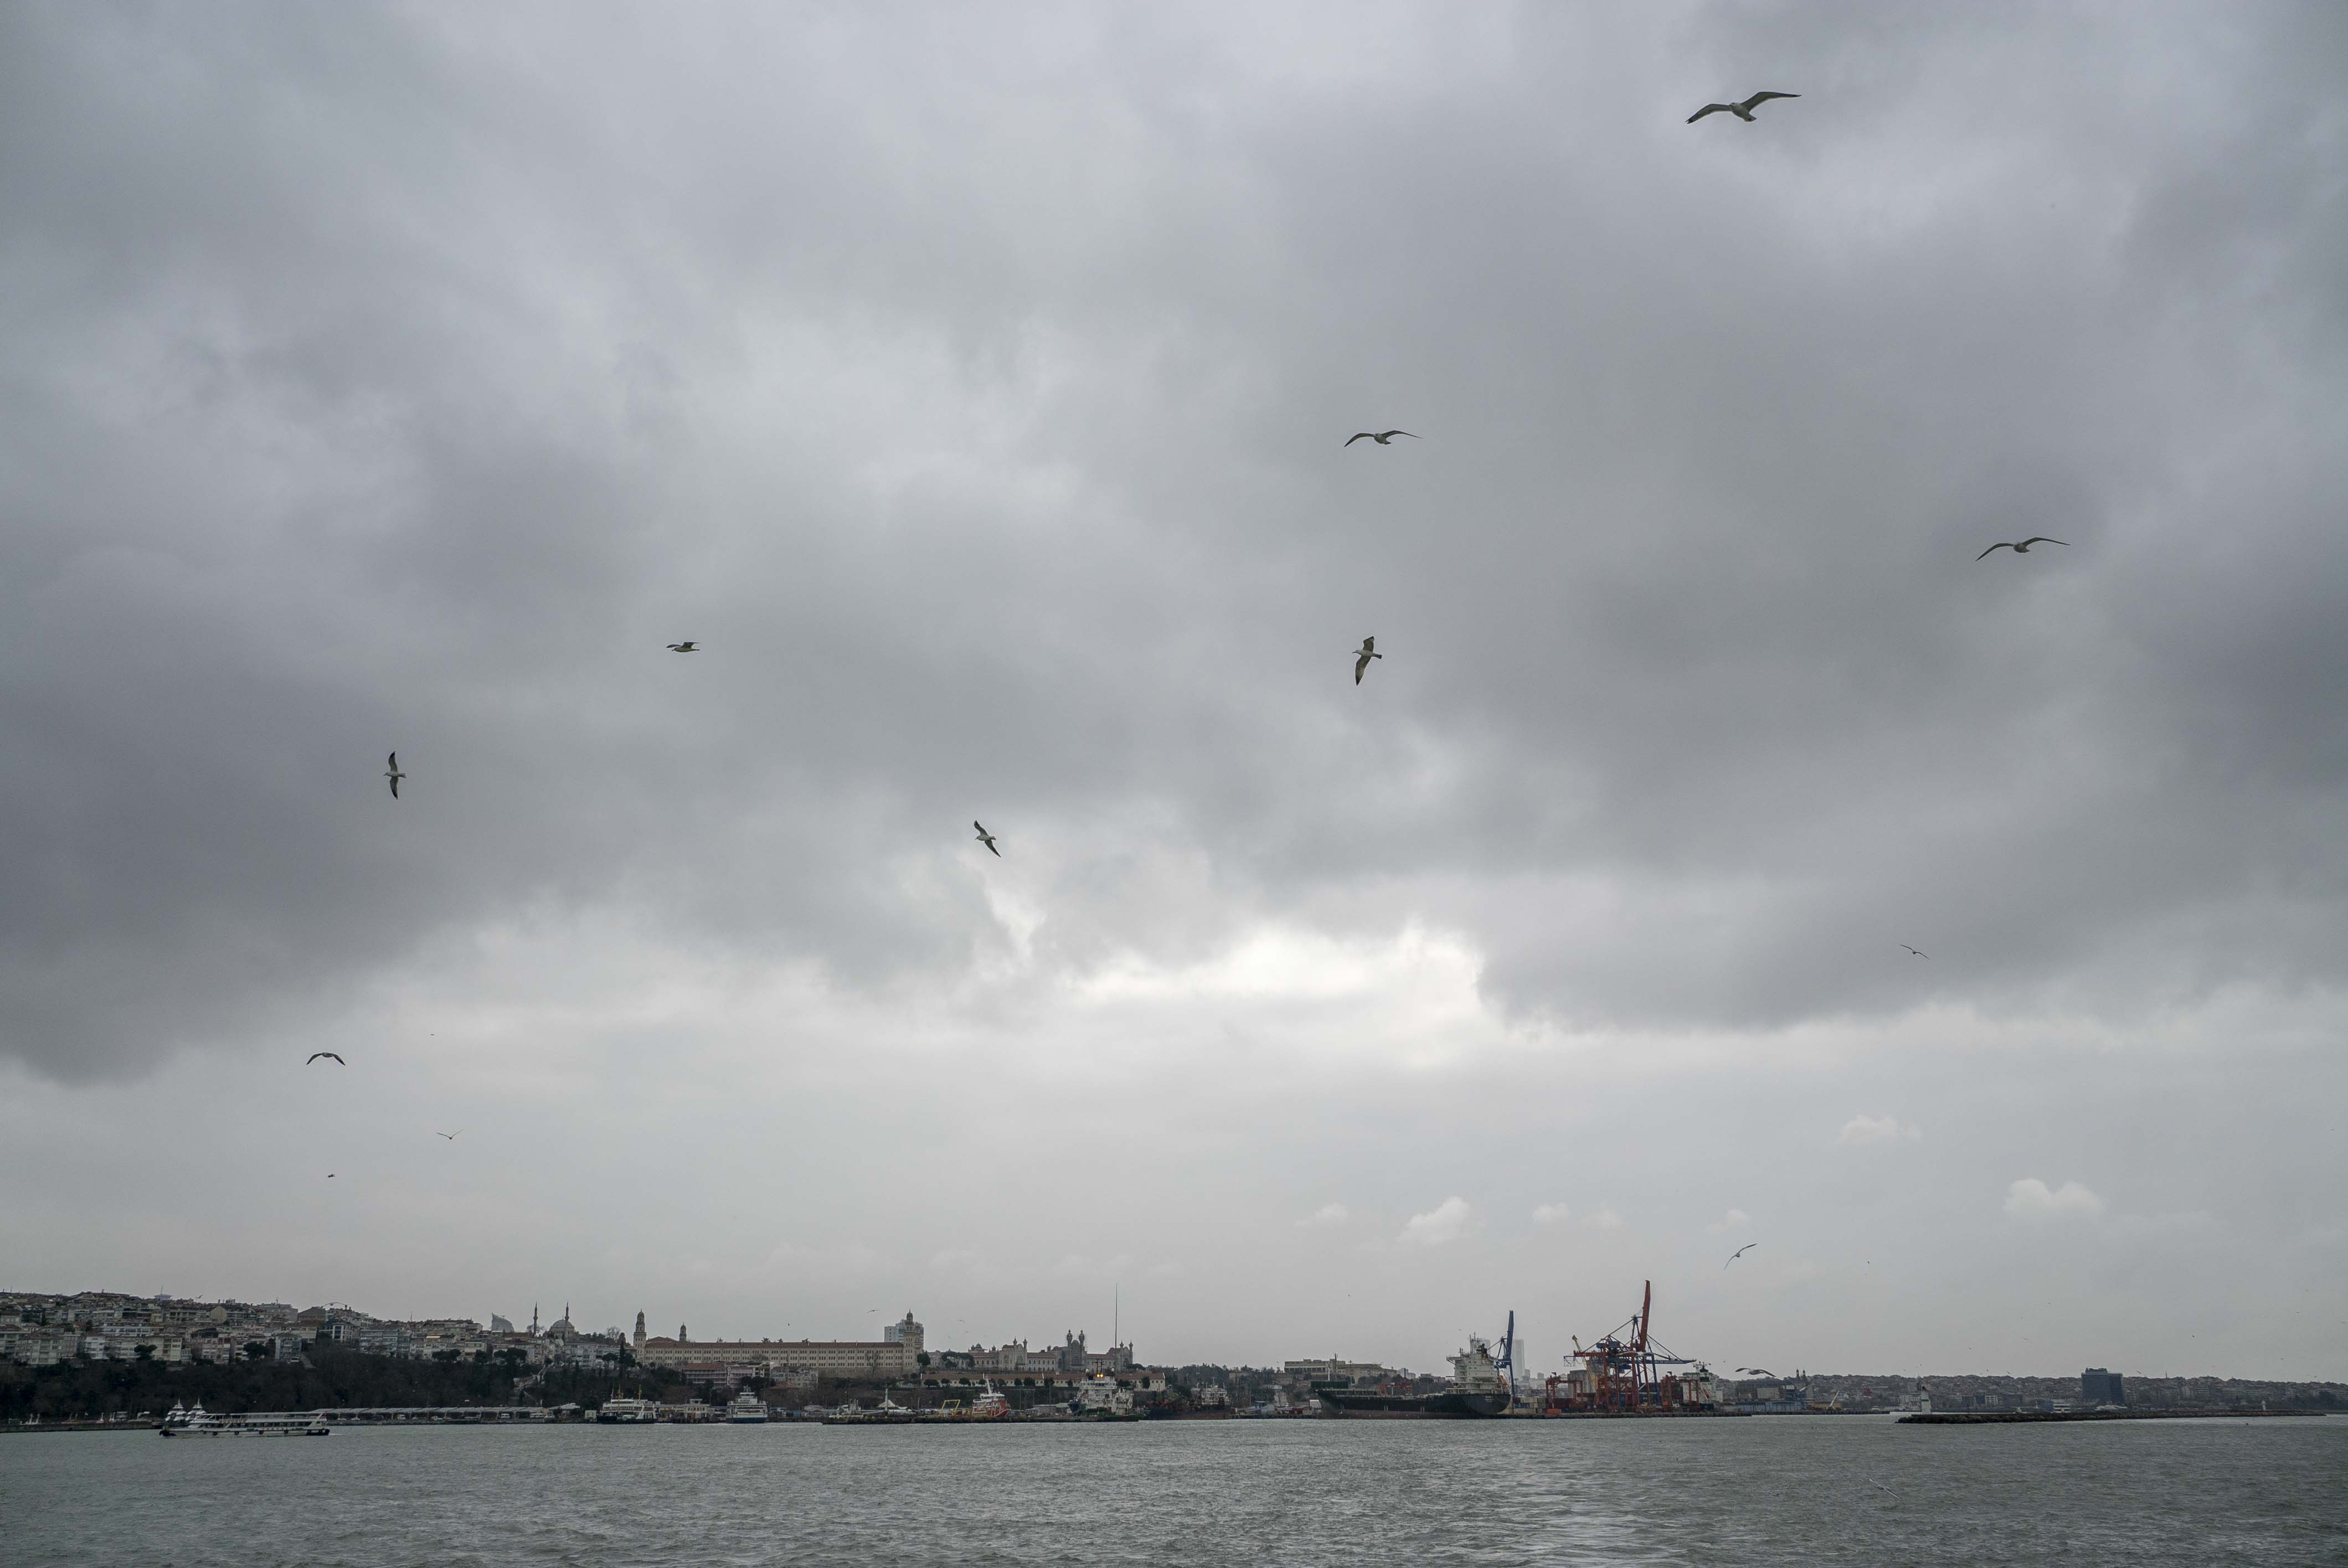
[[0, 0, 2348, 1378]]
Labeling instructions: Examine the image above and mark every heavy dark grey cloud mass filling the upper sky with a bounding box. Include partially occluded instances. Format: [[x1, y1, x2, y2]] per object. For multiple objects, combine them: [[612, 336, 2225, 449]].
[[0, 7, 2348, 1077]]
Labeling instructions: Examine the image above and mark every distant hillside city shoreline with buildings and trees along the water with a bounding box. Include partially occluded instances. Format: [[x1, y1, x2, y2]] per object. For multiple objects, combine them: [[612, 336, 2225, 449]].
[[0, 1291, 2348, 1415]]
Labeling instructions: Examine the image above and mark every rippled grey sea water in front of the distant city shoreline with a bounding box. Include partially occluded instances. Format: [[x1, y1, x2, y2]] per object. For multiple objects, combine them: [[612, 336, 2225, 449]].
[[0, 1415, 2348, 1568]]
